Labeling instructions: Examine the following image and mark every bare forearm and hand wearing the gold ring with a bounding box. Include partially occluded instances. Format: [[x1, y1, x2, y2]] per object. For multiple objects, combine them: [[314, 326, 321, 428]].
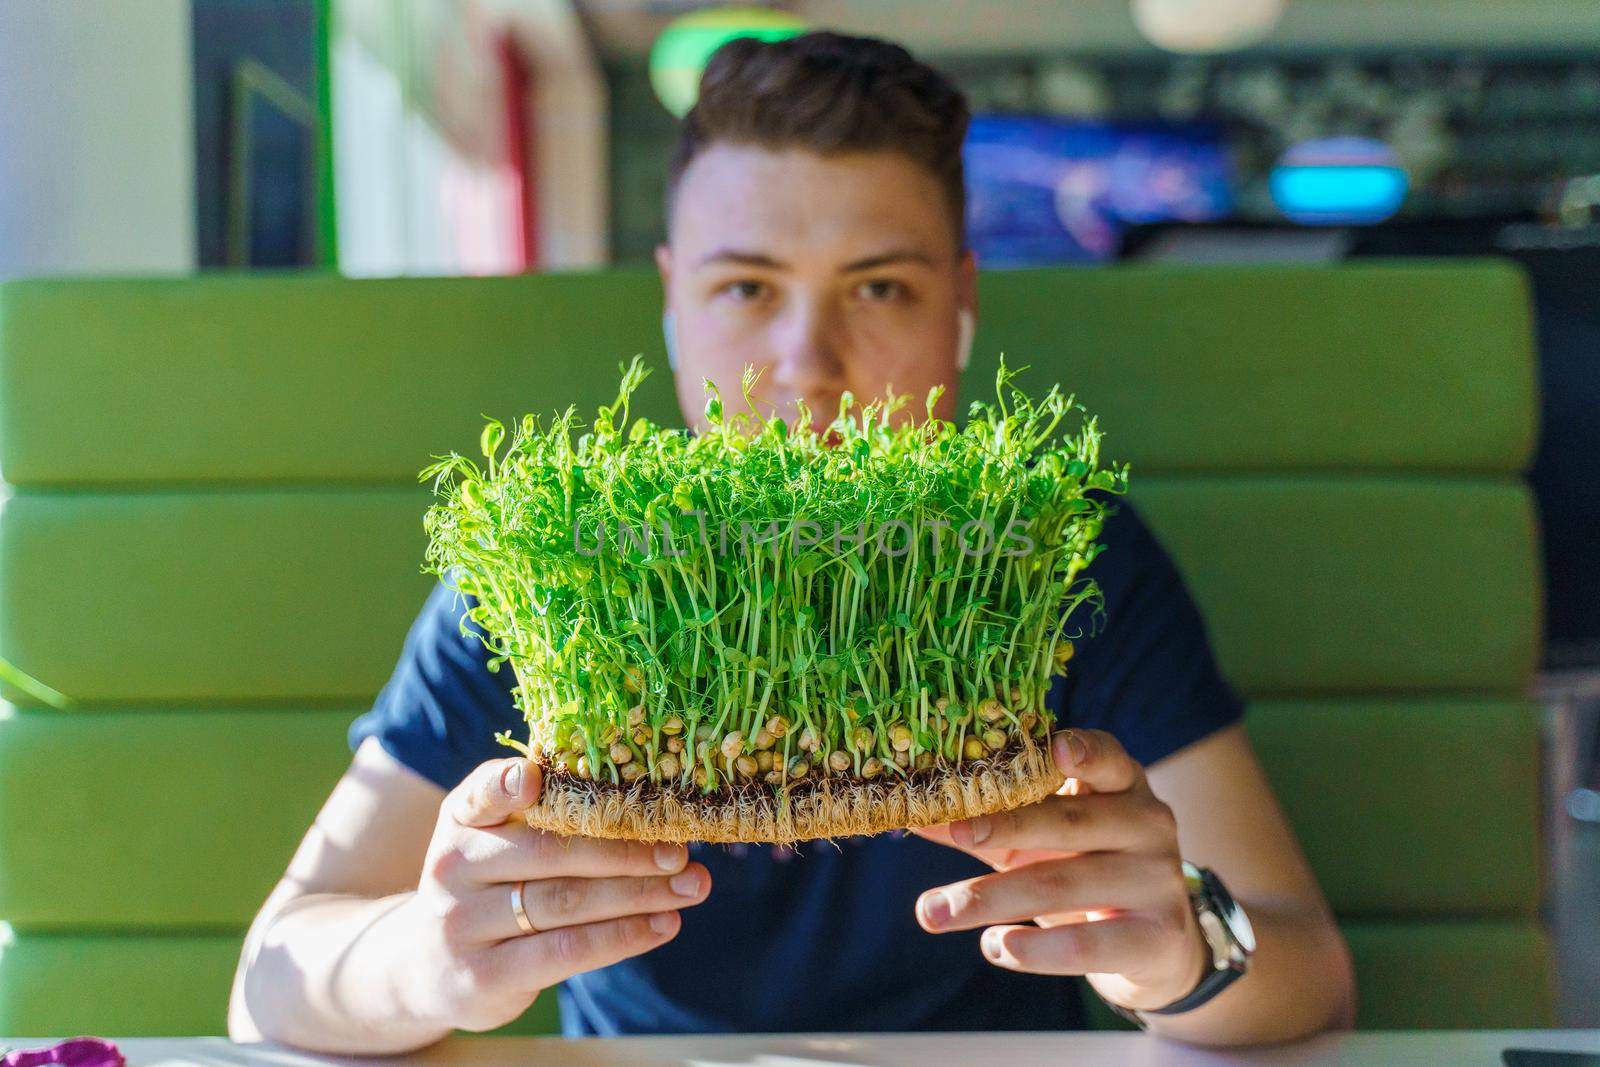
[[229, 739, 710, 1056]]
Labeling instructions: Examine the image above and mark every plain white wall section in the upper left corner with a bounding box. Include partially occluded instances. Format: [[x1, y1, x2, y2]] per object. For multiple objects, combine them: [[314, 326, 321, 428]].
[[0, 0, 195, 277]]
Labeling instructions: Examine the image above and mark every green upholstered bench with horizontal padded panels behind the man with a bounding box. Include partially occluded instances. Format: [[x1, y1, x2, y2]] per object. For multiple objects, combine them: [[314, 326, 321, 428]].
[[0, 262, 1552, 1035]]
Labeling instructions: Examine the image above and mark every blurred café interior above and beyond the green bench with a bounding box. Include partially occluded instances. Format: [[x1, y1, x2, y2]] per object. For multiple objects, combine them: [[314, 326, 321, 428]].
[[0, 0, 1600, 1025]]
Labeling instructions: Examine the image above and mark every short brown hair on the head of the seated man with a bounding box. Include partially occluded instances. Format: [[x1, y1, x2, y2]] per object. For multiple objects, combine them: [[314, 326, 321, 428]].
[[667, 32, 970, 248]]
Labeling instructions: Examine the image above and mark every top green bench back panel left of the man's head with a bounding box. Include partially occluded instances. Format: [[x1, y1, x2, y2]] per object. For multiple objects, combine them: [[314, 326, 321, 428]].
[[0, 272, 678, 485]]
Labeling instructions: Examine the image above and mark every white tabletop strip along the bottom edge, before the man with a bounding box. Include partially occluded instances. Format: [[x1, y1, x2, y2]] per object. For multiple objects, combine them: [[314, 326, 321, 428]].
[[0, 1030, 1600, 1067]]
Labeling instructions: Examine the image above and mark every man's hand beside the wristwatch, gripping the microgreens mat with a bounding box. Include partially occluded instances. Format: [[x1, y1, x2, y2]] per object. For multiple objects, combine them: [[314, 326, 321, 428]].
[[917, 729, 1210, 1008]]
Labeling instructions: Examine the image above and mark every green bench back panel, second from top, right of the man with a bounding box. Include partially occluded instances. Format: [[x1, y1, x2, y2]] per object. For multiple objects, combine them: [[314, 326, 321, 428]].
[[1139, 475, 1542, 694]]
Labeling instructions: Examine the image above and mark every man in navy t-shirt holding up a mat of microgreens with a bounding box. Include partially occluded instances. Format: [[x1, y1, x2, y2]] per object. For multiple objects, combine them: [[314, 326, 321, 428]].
[[230, 34, 1354, 1053]]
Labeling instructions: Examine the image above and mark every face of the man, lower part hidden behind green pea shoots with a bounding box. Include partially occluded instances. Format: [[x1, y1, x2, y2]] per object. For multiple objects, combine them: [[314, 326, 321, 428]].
[[656, 144, 976, 429]]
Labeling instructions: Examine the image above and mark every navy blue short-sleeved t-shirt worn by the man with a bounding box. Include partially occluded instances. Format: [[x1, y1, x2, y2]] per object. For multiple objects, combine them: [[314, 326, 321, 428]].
[[350, 502, 1242, 1035]]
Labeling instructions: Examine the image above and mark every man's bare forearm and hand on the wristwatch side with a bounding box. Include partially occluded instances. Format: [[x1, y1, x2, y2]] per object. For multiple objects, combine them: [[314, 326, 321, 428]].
[[917, 725, 1355, 1045]]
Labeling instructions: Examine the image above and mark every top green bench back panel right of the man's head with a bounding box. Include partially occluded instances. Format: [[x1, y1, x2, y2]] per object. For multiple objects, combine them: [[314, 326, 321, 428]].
[[966, 261, 1538, 474]]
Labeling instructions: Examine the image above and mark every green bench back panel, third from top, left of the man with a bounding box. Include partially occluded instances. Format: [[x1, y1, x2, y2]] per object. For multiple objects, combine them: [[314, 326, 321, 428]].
[[0, 709, 357, 929]]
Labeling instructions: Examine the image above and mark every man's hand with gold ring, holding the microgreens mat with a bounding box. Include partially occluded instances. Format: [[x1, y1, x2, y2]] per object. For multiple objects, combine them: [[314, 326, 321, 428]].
[[398, 758, 710, 1030]]
